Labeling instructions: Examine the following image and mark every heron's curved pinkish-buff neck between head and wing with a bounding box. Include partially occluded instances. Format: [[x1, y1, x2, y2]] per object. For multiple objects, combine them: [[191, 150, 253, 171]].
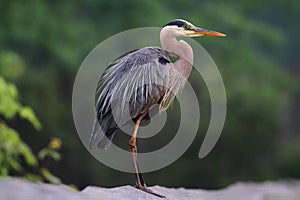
[[160, 28, 194, 78]]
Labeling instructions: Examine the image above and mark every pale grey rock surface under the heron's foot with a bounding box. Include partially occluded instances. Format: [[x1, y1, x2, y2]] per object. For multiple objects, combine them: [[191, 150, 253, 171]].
[[0, 178, 300, 200]]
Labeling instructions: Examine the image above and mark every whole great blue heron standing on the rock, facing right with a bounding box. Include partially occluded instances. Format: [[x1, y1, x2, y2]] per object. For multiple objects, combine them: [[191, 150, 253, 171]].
[[90, 19, 225, 197]]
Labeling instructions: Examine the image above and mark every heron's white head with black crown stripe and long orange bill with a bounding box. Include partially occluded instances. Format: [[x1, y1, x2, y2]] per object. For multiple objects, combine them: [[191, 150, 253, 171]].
[[164, 19, 226, 37]]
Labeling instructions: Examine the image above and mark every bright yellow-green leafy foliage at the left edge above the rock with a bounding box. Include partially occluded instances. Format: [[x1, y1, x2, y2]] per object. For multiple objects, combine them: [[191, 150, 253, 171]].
[[0, 76, 61, 184]]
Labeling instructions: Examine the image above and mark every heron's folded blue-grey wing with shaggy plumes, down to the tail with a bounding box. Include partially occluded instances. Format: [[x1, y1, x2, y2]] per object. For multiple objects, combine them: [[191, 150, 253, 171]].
[[90, 47, 170, 148]]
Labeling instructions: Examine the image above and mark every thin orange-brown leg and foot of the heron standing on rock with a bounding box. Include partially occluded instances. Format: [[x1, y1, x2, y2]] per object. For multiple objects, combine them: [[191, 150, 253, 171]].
[[129, 114, 165, 198]]
